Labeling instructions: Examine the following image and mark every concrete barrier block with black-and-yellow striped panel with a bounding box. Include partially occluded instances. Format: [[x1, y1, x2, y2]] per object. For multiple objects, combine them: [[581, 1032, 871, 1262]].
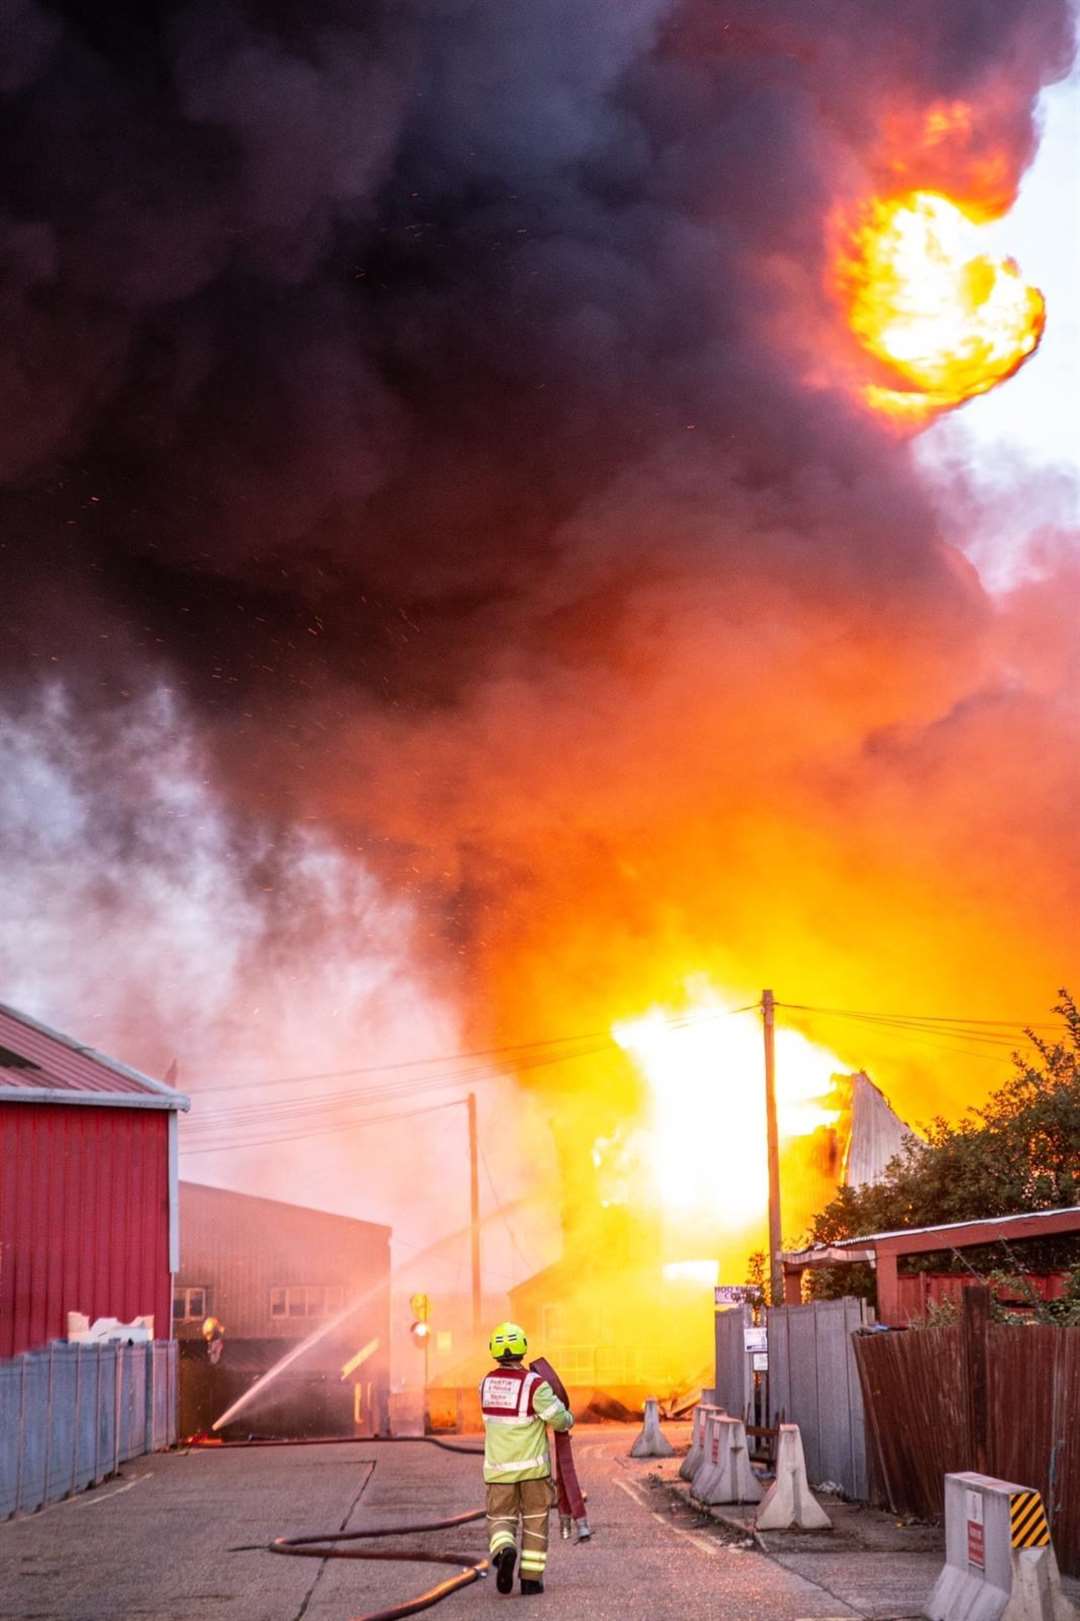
[[926, 1472, 1077, 1621]]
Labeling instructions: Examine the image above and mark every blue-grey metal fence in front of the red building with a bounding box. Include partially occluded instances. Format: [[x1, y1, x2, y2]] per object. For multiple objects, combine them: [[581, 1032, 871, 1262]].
[[0, 1341, 177, 1519]]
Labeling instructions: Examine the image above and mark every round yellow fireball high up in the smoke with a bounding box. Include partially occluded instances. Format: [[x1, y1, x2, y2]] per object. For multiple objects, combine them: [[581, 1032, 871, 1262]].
[[834, 191, 1046, 425]]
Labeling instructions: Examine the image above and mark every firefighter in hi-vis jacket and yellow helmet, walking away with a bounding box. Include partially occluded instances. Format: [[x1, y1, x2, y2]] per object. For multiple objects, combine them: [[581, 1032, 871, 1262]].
[[480, 1323, 574, 1595]]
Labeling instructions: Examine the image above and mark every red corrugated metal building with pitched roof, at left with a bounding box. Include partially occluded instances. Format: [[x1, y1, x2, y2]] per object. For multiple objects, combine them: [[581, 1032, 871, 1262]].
[[0, 1003, 188, 1357]]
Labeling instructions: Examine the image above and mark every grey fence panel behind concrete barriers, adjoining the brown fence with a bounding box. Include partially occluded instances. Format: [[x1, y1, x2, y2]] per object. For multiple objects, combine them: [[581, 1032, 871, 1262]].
[[769, 1298, 868, 1499]]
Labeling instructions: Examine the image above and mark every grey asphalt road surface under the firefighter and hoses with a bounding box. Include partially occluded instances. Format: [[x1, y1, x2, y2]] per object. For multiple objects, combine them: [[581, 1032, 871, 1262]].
[[0, 1425, 960, 1621]]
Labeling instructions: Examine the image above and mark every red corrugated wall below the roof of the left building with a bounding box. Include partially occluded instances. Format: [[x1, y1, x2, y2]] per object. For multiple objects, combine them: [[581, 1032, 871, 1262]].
[[0, 1102, 172, 1357]]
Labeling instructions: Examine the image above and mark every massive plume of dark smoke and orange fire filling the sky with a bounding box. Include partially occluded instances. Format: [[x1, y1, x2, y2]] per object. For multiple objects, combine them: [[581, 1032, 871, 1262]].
[[0, 0, 1080, 1394]]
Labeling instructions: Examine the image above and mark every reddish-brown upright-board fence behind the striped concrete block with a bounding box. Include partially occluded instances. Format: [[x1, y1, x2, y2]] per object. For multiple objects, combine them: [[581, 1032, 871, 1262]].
[[855, 1289, 1080, 1574]]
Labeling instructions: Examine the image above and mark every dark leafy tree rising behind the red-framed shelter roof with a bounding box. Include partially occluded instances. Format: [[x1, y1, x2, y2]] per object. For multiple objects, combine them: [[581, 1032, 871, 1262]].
[[811, 990, 1080, 1298]]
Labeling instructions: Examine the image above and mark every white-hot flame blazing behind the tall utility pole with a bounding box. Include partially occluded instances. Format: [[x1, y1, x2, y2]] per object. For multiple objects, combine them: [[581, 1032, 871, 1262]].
[[611, 997, 843, 1230]]
